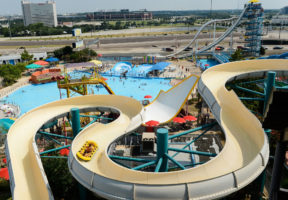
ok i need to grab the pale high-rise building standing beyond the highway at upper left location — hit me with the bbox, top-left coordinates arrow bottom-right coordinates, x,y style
21,0 -> 58,27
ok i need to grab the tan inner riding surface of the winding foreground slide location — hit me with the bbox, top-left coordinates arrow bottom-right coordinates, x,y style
6,60 -> 288,199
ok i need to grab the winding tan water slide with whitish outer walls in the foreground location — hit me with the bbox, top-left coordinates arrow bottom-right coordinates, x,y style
6,60 -> 288,200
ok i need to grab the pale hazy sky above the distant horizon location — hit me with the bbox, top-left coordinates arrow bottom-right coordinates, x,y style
0,0 -> 288,16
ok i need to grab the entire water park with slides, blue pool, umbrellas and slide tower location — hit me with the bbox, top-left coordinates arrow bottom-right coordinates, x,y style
0,0 -> 288,200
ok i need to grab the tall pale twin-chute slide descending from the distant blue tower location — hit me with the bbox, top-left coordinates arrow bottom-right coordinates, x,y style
167,4 -> 247,57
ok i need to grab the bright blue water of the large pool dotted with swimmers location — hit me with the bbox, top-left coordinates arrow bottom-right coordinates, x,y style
1,74 -> 171,115
